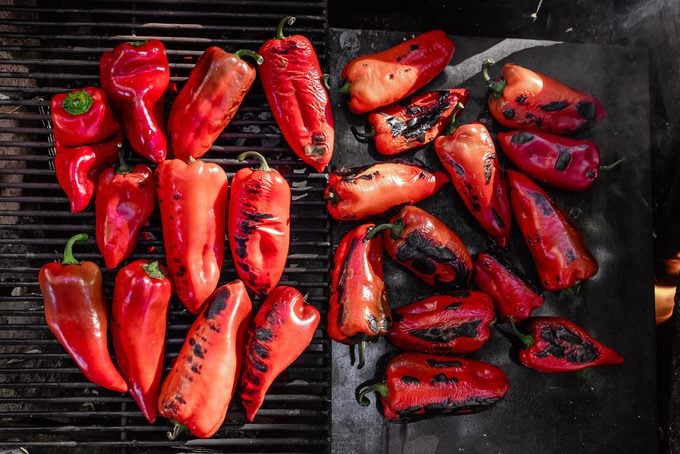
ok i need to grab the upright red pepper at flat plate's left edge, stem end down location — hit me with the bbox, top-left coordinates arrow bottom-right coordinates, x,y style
327,224 -> 392,368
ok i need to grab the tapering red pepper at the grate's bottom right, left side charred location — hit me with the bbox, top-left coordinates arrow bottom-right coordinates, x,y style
241,286 -> 321,422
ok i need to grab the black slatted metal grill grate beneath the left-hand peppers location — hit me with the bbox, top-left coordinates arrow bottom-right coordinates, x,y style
0,0 -> 331,453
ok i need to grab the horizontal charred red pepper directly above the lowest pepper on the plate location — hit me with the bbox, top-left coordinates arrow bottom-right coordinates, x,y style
387,290 -> 496,355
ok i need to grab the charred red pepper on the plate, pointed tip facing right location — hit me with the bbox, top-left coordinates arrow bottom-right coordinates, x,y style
513,317 -> 623,372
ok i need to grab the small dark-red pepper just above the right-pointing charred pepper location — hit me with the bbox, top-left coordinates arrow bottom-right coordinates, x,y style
474,252 -> 545,321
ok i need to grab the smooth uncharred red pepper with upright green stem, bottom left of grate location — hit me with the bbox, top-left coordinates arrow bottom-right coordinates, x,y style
38,233 -> 128,392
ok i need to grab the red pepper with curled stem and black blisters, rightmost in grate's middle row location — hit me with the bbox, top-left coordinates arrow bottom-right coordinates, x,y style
227,151 -> 291,296
